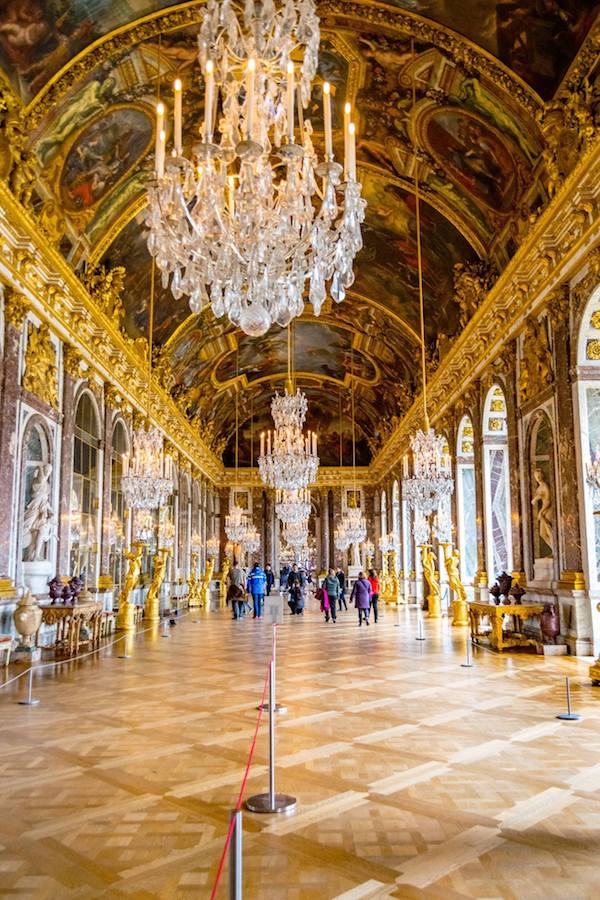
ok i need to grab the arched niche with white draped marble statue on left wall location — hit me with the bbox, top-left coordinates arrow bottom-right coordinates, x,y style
21,421 -> 54,561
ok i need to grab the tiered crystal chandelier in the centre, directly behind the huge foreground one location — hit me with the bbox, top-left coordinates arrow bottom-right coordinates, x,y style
258,384 -> 319,491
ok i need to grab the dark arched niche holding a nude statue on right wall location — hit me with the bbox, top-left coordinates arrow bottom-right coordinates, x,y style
529,413 -> 557,581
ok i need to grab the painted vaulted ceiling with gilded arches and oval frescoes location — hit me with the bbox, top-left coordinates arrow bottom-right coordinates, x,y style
0,0 -> 600,464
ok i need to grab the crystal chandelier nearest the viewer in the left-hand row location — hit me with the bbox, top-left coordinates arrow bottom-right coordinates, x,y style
121,428 -> 173,509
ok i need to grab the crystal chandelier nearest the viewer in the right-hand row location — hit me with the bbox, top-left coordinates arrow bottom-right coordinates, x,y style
403,428 -> 454,516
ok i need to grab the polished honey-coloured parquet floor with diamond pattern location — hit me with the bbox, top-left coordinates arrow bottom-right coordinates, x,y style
0,602 -> 600,900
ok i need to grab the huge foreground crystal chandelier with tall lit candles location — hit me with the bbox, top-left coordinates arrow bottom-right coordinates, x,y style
147,0 -> 366,336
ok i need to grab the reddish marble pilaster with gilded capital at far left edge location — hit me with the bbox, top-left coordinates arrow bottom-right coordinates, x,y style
0,287 -> 28,584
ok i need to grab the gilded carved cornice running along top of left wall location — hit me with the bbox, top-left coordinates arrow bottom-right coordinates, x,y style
0,180 -> 224,481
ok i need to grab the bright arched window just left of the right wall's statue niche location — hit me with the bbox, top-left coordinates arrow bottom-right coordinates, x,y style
483,384 -> 512,577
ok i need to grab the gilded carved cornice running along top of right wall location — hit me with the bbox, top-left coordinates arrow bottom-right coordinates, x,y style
370,140 -> 600,483
